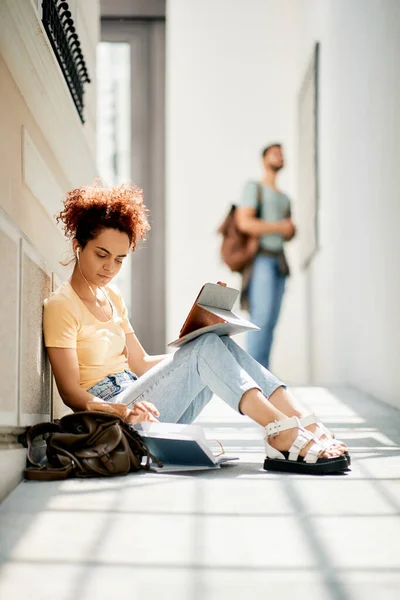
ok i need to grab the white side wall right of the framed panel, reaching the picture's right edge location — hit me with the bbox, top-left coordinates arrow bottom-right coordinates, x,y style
299,0 -> 400,407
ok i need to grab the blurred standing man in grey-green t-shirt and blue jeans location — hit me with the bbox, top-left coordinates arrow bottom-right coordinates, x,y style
236,144 -> 295,369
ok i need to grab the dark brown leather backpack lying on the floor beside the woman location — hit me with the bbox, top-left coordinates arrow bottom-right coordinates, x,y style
24,411 -> 162,481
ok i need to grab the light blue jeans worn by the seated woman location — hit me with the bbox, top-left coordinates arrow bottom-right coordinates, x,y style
88,333 -> 284,423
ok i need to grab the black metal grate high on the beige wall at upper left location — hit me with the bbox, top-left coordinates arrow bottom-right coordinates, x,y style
42,0 -> 90,123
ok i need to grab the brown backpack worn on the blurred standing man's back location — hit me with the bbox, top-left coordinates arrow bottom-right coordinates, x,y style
218,183 -> 262,273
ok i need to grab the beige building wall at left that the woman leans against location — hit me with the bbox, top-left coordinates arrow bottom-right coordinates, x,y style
0,0 -> 100,499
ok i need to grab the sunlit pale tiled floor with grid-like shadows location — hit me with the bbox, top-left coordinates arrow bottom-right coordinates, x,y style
0,388 -> 400,600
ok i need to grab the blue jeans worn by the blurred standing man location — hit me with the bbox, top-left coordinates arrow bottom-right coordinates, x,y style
247,254 -> 286,369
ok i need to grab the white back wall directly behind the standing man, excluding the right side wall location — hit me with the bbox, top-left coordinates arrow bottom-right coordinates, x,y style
167,0 -> 306,382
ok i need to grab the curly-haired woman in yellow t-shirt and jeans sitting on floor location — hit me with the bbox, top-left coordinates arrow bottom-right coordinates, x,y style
44,185 -> 349,474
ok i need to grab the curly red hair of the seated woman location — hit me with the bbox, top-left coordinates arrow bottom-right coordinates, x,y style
56,183 -> 150,251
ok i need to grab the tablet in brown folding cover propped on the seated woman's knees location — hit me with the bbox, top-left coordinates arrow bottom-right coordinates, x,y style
168,283 -> 260,347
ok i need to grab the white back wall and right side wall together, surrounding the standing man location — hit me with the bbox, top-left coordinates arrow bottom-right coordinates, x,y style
167,0 -> 400,406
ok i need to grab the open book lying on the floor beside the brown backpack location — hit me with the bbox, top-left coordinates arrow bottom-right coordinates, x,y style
138,421 -> 239,473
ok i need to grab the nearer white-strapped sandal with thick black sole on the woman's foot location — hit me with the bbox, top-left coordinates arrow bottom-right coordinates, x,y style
264,417 -> 348,475
